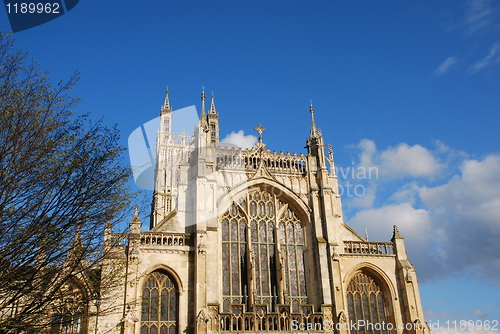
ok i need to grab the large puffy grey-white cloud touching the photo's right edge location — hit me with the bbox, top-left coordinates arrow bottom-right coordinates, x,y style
419,154 -> 500,283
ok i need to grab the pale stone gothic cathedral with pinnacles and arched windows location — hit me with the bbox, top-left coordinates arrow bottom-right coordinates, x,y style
97,91 -> 429,334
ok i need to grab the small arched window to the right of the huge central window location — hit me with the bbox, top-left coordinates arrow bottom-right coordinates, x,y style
347,271 -> 391,334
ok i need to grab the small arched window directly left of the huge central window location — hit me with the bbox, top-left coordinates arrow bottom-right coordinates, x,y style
141,271 -> 179,334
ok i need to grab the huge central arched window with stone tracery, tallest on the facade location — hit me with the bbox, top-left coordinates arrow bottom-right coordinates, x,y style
221,190 -> 307,312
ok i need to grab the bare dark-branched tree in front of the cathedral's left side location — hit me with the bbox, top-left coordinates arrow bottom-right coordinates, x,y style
0,33 -> 133,333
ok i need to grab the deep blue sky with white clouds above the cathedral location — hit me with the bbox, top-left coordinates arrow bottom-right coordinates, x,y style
0,0 -> 500,333
